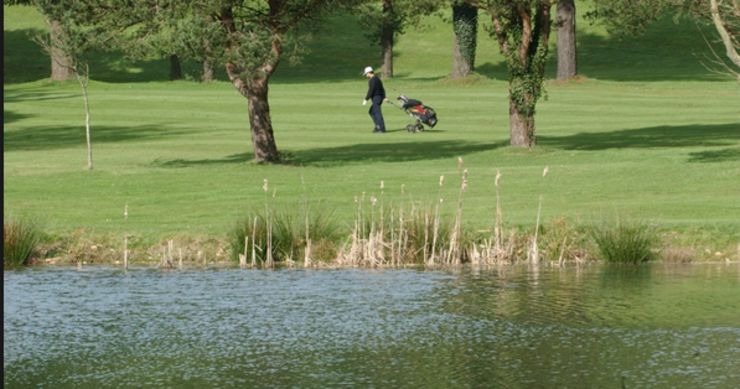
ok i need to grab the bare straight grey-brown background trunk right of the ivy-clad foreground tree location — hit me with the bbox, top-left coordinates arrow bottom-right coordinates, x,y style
556,0 -> 578,80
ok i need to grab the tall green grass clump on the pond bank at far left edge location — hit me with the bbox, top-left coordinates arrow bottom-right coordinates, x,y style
3,215 -> 41,266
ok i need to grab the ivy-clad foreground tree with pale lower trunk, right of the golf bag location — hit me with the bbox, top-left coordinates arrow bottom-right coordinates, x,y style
467,0 -> 552,147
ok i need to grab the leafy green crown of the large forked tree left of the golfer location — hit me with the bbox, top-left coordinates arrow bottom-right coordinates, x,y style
98,0 -> 341,80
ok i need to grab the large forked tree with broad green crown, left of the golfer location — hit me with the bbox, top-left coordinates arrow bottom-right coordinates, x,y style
89,0 -> 353,163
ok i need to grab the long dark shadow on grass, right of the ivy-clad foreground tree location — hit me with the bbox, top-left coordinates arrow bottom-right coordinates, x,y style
537,123 -> 740,162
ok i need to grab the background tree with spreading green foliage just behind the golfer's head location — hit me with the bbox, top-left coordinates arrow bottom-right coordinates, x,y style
350,0 -> 442,78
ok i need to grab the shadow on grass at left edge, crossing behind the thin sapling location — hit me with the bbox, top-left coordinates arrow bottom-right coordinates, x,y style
3,123 -> 186,151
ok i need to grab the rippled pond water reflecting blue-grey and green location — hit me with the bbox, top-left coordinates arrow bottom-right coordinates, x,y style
3,264 -> 740,389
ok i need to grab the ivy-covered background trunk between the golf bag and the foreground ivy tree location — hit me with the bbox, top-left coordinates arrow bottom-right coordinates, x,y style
450,1 -> 478,78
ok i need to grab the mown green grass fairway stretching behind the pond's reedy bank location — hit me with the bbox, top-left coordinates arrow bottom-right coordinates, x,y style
3,7 -> 740,260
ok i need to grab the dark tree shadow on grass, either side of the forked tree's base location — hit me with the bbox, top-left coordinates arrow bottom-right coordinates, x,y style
154,141 -> 508,168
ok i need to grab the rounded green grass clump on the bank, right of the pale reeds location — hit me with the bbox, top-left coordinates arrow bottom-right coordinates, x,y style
588,215 -> 659,264
